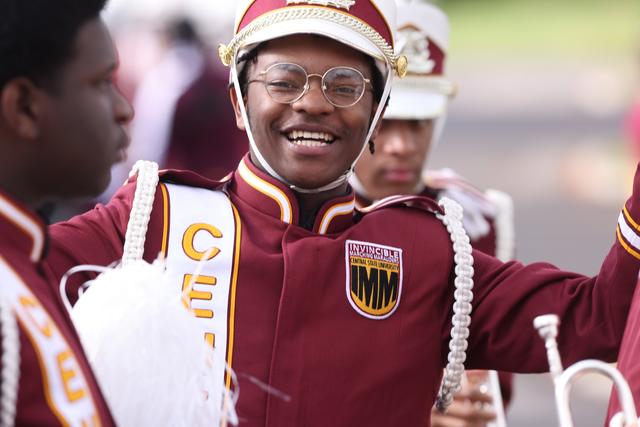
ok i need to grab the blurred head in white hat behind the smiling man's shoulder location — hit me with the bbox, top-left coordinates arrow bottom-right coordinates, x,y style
351,1 -> 455,200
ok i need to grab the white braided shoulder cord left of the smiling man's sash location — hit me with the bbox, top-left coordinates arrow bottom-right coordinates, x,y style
122,160 -> 158,265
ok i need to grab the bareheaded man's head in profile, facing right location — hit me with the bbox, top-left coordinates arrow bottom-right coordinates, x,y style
0,0 -> 132,205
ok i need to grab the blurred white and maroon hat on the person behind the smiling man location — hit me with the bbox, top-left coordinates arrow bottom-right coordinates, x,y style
384,0 -> 456,120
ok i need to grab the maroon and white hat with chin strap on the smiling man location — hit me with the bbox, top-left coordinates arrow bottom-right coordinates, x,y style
218,0 -> 407,193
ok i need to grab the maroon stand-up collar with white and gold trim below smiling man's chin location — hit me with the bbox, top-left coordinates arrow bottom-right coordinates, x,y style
231,155 -> 355,234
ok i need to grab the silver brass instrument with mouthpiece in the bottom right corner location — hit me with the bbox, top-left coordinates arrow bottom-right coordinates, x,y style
533,314 -> 640,427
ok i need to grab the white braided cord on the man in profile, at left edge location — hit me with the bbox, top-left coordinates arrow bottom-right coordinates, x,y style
0,295 -> 20,427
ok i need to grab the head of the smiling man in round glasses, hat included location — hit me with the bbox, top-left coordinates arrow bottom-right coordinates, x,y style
220,0 -> 404,199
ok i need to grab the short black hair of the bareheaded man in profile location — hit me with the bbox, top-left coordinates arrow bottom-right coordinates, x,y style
0,0 -> 107,89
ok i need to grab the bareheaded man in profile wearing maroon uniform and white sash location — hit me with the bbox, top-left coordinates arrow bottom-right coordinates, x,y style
0,0 -> 132,426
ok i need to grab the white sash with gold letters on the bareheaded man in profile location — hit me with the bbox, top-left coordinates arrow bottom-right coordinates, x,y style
0,257 -> 100,426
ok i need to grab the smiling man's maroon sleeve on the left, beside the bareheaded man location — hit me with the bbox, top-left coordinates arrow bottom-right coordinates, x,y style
44,181 -> 163,301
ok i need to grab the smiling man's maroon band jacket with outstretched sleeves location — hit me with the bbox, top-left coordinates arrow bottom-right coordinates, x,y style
49,157 -> 640,426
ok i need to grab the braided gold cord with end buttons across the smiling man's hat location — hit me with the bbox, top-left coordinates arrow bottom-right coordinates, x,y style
218,7 -> 408,77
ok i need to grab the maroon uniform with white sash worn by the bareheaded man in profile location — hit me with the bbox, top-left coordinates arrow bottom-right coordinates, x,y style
0,190 -> 114,426
